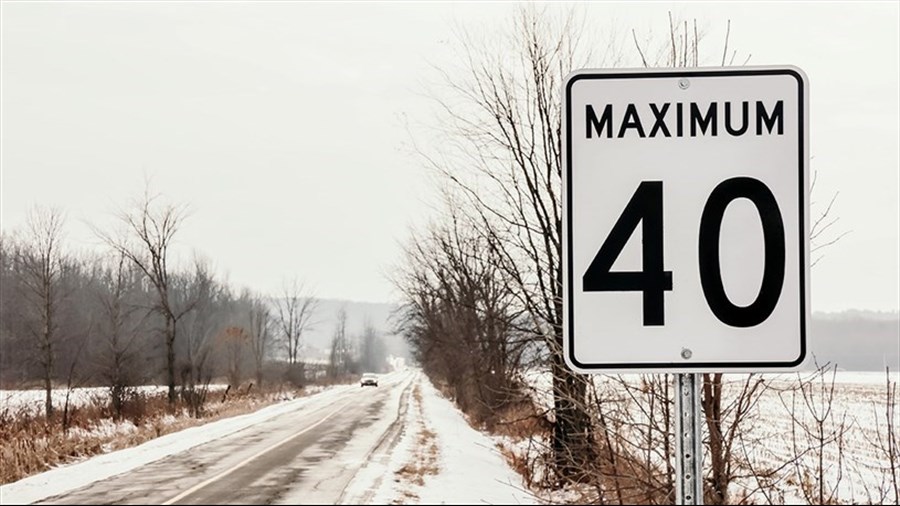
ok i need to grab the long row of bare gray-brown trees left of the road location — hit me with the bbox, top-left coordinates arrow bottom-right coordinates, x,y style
0,192 -> 386,418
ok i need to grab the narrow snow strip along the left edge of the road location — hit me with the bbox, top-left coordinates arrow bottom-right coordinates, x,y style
0,385 -> 356,504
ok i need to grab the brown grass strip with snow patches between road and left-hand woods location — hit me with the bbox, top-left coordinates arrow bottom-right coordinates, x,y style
0,375 -> 372,484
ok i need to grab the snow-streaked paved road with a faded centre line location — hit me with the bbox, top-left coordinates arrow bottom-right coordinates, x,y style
41,373 -> 415,504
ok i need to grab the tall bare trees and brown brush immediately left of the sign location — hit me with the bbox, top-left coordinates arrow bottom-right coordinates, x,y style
396,9 -> 605,483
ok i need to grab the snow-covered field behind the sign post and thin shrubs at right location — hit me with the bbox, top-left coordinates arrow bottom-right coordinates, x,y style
527,371 -> 900,504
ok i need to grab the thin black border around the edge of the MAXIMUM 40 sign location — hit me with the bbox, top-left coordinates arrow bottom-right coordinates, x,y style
563,68 -> 807,371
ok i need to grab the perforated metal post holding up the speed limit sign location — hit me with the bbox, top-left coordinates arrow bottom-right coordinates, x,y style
675,374 -> 703,504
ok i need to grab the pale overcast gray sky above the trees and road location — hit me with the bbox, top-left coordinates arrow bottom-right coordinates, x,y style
0,1 -> 900,311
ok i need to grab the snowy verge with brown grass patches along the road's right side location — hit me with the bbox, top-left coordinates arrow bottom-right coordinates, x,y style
347,374 -> 537,504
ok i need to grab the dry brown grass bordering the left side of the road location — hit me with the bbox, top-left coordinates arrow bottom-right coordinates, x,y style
0,389 -> 312,484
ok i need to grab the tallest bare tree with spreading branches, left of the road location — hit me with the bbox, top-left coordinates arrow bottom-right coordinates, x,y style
97,184 -> 192,404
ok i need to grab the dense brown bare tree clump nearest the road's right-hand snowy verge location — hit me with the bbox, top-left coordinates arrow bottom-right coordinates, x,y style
396,213 -> 534,427
